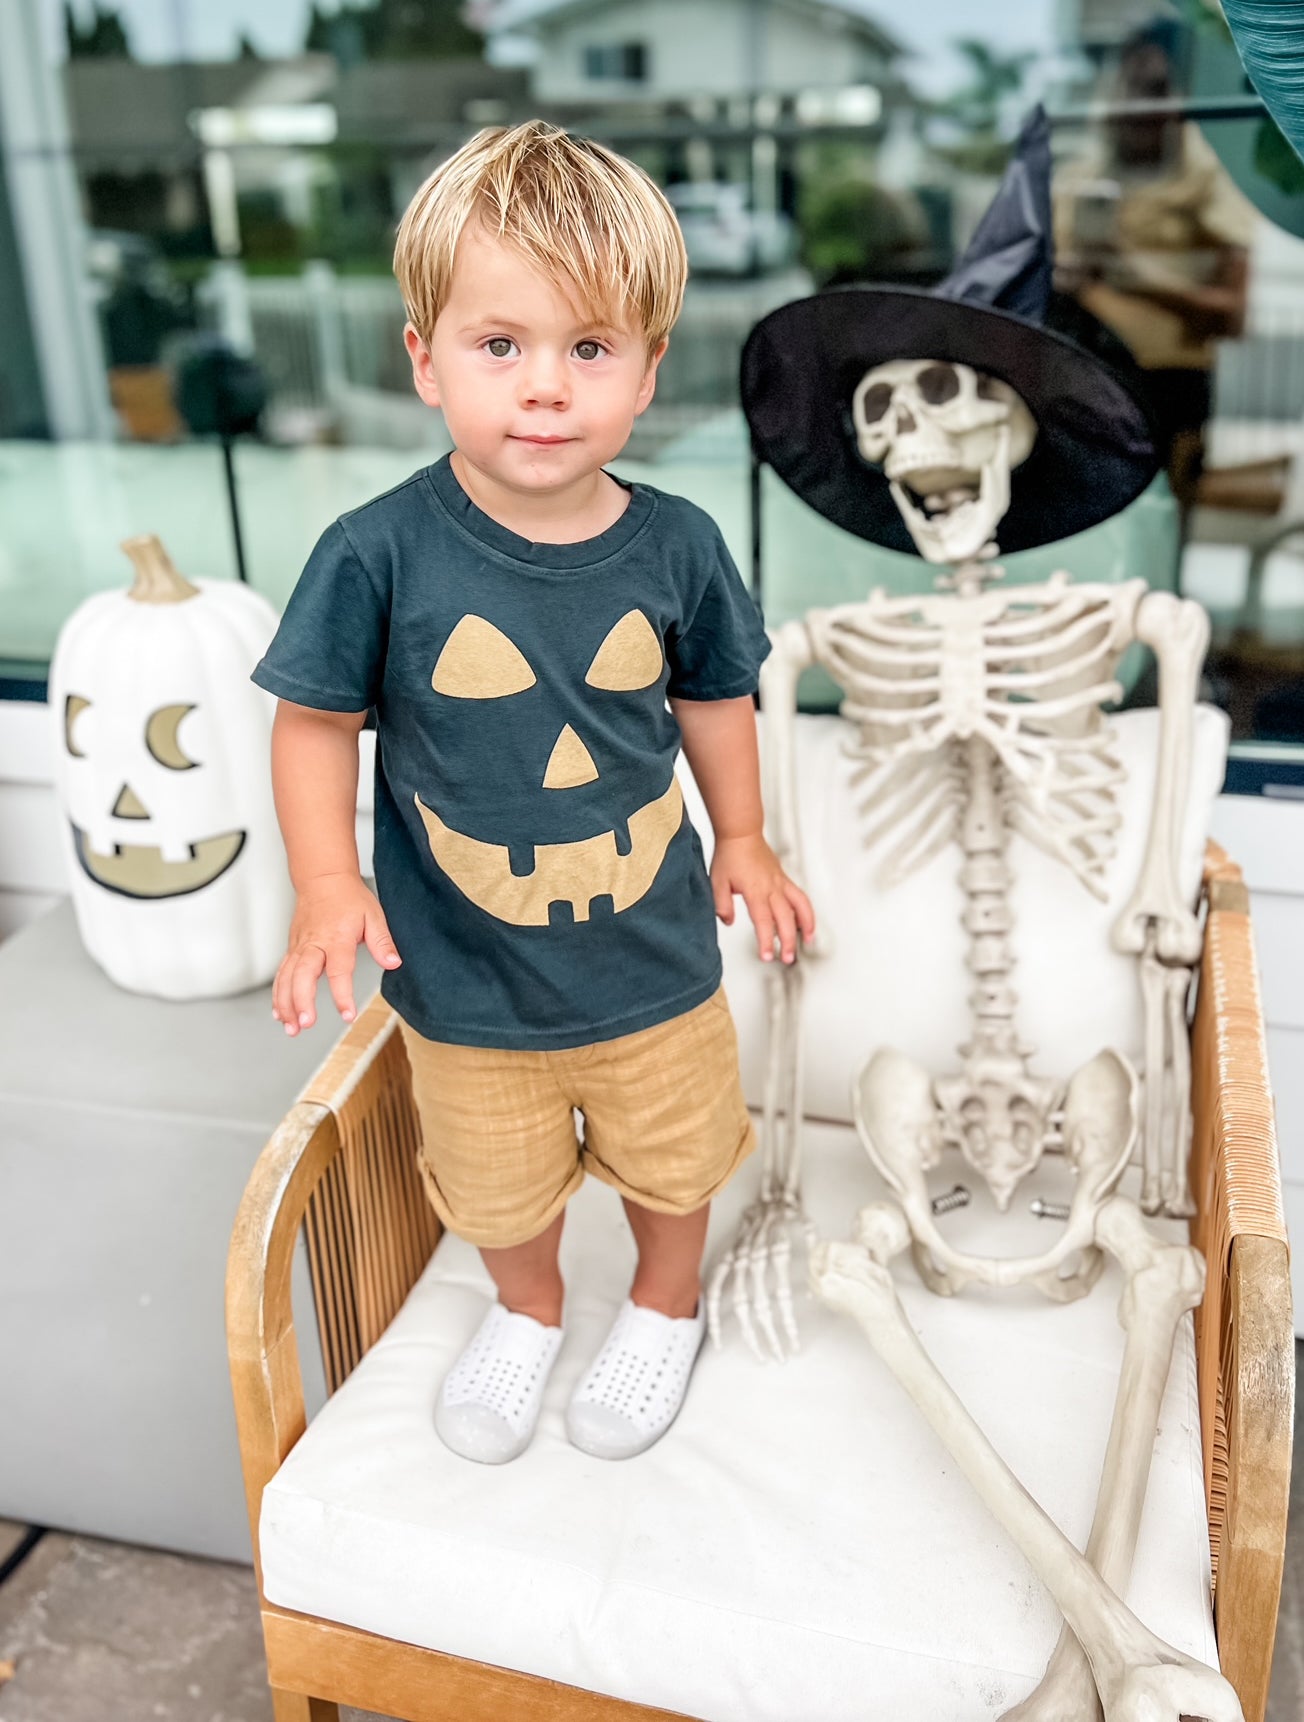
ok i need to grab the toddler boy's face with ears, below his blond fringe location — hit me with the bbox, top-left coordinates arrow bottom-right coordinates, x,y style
405,226 -> 667,494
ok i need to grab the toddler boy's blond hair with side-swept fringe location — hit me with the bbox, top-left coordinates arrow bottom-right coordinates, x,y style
394,119 -> 687,353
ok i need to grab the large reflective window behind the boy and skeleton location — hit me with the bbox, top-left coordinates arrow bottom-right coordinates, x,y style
0,0 -> 1304,761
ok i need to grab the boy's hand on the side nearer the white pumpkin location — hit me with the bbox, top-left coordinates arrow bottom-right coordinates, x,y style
272,873 -> 401,1035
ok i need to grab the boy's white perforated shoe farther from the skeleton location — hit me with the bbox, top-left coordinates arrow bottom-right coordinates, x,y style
434,1304 -> 562,1465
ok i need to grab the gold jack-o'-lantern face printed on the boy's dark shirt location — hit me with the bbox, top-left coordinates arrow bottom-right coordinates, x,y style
415,610 -> 684,926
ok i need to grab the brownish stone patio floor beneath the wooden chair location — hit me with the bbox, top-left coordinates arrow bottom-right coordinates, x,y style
0,1343 -> 1304,1722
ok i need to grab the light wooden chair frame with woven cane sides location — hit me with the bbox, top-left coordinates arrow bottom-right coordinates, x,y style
227,846 -> 1295,1722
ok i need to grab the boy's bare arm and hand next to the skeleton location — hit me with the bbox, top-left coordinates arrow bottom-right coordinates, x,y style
670,694 -> 815,963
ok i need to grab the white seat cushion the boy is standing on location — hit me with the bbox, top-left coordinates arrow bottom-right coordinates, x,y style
260,1124 -> 1216,1722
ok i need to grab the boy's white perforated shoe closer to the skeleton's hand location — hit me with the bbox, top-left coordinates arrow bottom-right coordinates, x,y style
567,1298 -> 706,1459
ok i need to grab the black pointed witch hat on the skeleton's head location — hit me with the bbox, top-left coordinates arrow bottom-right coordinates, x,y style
741,107 -> 1159,551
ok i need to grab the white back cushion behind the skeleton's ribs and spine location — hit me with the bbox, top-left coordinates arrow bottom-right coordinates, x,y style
684,706 -> 1228,1123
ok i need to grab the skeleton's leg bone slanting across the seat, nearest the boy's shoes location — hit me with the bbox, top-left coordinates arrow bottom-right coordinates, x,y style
811,1239 -> 1244,1722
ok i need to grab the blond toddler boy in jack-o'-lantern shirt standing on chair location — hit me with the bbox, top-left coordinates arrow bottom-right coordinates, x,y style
255,121 -> 813,1462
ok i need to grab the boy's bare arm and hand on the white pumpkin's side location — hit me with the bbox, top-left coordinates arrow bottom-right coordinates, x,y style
272,699 -> 400,1035
